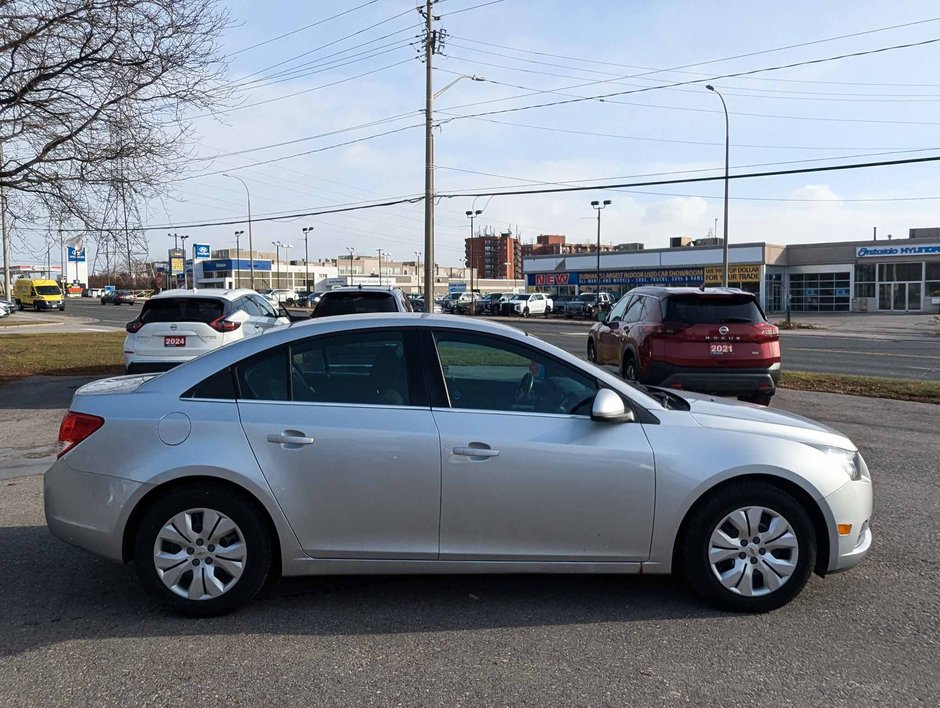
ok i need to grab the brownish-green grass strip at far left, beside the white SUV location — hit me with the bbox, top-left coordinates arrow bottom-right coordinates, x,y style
0,332 -> 125,381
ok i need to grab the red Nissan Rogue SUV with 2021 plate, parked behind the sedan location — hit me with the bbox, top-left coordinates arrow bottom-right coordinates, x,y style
587,287 -> 780,405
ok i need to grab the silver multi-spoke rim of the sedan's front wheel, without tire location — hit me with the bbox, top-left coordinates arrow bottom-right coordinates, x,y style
708,506 -> 800,597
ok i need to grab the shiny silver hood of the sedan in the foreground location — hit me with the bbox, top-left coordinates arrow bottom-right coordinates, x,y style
673,391 -> 857,450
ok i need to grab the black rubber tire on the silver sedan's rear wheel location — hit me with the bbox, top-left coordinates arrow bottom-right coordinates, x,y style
134,484 -> 273,617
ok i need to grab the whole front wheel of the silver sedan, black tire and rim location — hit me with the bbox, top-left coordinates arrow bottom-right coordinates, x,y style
678,481 -> 816,612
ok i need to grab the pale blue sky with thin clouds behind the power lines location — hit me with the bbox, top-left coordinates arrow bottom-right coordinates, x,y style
86,0 -> 940,265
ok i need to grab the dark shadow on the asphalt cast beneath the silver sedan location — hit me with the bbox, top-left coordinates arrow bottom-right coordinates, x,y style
0,526 -> 721,657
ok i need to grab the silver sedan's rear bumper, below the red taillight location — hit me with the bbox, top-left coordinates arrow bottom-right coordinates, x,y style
43,459 -> 150,561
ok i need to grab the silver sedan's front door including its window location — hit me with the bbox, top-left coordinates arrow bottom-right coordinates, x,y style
427,330 -> 655,561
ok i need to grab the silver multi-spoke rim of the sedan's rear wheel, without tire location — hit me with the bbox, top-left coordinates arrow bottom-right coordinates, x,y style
153,508 -> 247,600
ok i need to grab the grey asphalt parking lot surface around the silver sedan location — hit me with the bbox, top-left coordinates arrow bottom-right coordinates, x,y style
0,387 -> 940,706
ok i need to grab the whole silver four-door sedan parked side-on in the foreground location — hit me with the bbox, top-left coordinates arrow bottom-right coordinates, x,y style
45,314 -> 872,615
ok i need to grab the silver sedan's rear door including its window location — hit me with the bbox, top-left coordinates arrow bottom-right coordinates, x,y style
237,330 -> 441,559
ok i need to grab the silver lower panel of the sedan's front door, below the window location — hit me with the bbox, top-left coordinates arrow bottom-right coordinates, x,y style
434,409 -> 655,561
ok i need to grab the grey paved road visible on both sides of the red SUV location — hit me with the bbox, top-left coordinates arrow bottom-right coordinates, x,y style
510,319 -> 940,381
